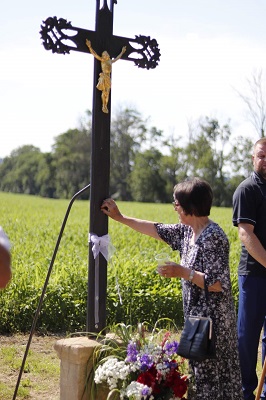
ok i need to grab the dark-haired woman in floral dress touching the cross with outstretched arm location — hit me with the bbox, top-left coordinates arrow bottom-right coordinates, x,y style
101,178 -> 243,400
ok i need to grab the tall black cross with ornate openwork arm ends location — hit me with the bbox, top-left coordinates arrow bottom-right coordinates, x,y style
40,0 -> 160,332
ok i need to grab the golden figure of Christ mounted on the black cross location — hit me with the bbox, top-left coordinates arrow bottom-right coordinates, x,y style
86,39 -> 127,113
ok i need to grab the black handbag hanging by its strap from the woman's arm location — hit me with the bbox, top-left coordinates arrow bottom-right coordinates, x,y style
177,280 -> 216,361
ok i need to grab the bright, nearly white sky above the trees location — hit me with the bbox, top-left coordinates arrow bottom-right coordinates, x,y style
0,0 -> 266,158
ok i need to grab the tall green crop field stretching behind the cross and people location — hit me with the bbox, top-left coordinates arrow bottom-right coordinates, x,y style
0,193 -> 240,334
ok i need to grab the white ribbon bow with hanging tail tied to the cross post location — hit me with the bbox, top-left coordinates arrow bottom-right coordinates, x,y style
89,233 -> 115,328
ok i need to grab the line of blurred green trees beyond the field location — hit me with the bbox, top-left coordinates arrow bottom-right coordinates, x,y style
0,107 -> 253,206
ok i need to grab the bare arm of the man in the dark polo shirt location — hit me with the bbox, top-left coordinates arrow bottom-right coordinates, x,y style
238,223 -> 266,268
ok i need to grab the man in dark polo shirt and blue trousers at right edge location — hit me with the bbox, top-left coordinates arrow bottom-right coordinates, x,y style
233,138 -> 266,400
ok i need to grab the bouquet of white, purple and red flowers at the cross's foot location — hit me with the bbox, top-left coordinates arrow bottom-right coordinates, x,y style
94,327 -> 188,400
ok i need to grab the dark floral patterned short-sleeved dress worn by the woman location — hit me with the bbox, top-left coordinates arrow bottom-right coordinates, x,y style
155,222 -> 243,400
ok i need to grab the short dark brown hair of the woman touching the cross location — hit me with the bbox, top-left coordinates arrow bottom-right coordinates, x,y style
174,178 -> 213,217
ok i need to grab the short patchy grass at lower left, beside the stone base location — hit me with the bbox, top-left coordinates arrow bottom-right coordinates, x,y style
0,335 -> 60,400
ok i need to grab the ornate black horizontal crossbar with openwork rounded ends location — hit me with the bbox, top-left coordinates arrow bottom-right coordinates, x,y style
40,17 -> 161,69
